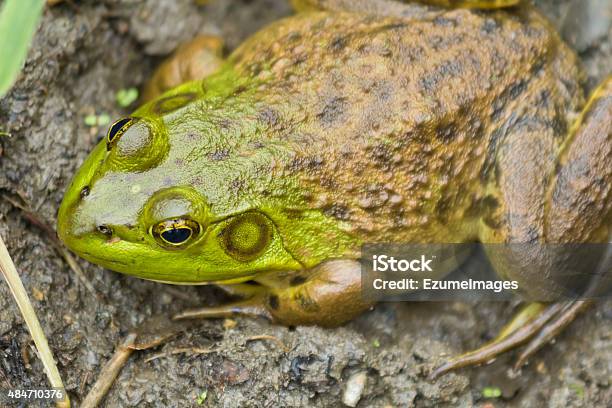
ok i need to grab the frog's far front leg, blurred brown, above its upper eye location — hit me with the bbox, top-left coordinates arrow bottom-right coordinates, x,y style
142,35 -> 223,102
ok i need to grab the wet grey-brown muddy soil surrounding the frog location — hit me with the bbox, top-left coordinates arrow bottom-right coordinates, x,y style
0,0 -> 612,407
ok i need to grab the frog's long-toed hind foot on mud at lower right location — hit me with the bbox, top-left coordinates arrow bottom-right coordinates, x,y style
430,300 -> 593,379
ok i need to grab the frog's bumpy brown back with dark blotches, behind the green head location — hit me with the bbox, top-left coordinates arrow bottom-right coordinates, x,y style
231,10 -> 582,240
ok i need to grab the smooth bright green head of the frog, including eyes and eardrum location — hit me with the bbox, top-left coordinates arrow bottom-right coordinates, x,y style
58,73 -> 358,283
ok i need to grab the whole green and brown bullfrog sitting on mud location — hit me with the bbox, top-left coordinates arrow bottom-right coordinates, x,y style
57,0 -> 612,375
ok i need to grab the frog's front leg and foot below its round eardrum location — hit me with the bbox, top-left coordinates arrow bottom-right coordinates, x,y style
175,260 -> 373,327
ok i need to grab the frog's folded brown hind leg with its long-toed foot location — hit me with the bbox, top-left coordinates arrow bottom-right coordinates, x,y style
433,76 -> 612,377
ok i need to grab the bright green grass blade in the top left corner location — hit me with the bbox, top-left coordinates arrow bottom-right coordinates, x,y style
0,0 -> 45,97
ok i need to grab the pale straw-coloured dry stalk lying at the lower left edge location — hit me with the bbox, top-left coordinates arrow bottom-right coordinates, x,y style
0,231 -> 70,407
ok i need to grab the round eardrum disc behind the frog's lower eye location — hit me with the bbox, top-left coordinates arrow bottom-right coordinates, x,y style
221,213 -> 272,262
